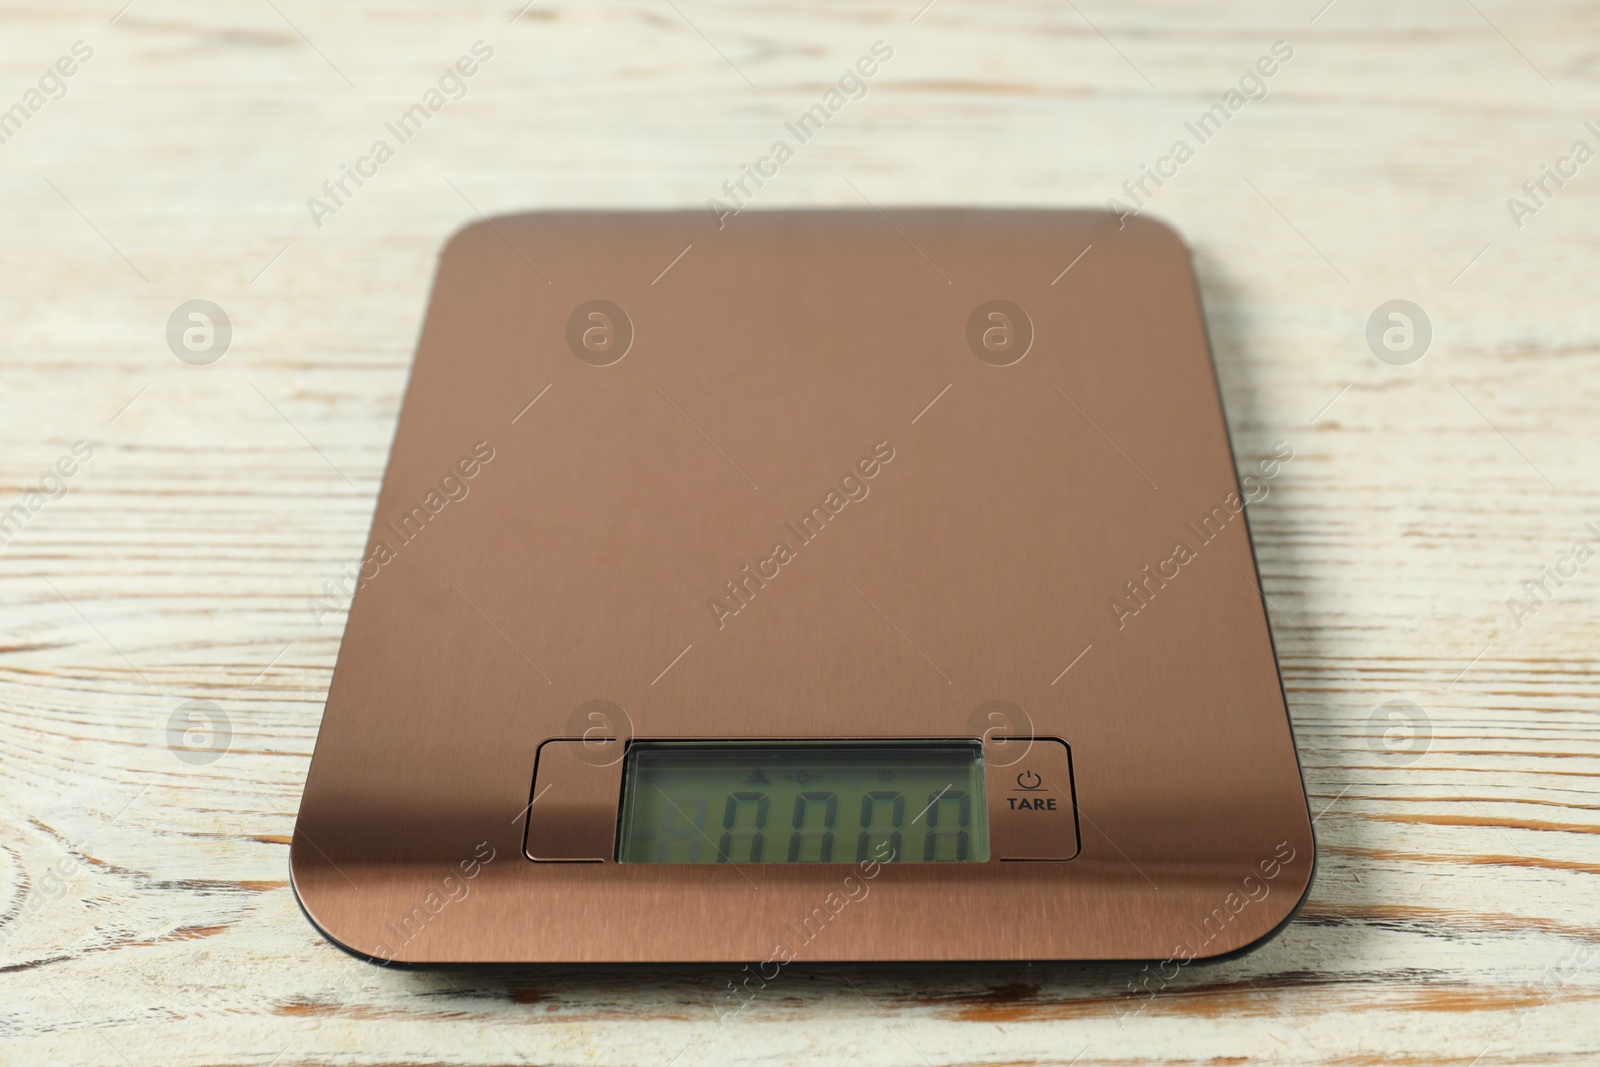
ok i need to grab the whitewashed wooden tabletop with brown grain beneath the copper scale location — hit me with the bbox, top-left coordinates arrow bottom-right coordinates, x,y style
0,0 -> 1600,1067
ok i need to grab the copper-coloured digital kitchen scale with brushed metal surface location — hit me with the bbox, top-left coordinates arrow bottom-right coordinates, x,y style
290,210 -> 1314,965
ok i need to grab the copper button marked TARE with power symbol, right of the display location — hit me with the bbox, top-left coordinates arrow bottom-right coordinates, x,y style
984,737 -> 1078,859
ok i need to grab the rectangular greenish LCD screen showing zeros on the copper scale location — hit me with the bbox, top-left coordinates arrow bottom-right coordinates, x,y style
618,742 -> 989,864
